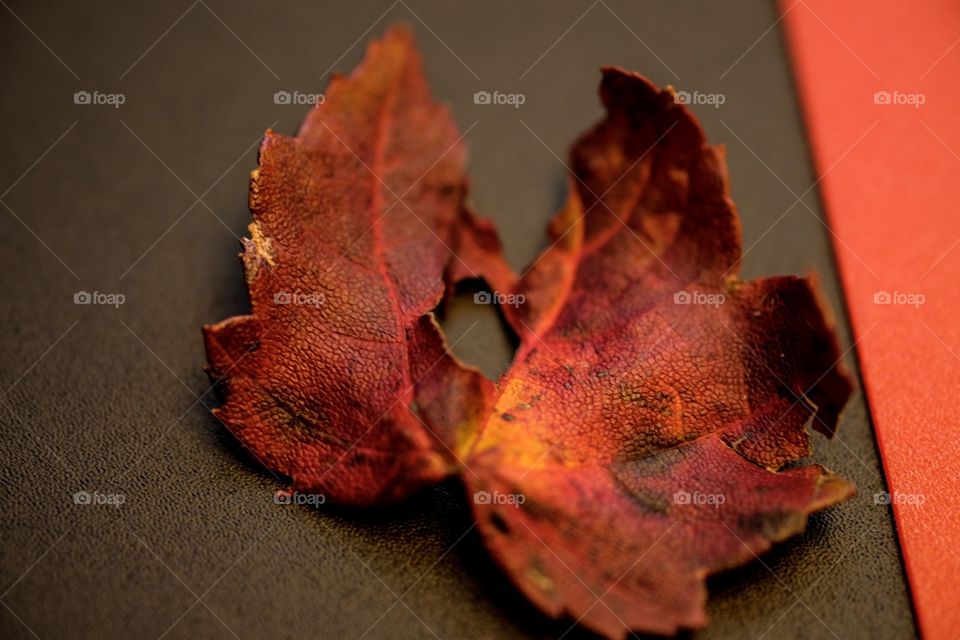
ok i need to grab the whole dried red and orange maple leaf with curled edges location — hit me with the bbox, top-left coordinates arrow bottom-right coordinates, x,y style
206,26 -> 854,637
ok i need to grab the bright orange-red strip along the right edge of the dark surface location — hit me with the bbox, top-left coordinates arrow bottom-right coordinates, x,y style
782,0 -> 960,640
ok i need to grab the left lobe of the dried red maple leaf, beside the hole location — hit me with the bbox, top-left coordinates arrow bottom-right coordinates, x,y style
204,26 -> 508,504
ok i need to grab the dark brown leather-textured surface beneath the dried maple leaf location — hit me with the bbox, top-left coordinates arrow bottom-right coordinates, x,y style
0,1 -> 915,639
